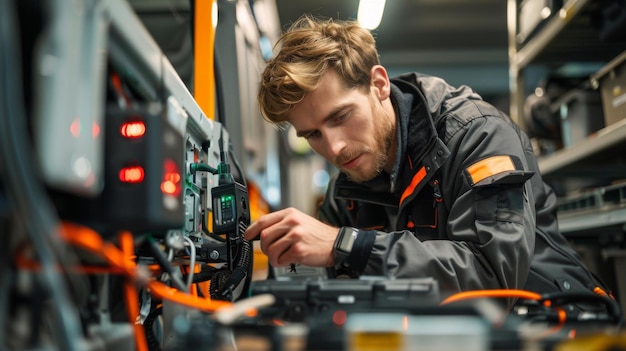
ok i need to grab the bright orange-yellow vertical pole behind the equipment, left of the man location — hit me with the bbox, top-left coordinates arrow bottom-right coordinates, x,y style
193,0 -> 217,119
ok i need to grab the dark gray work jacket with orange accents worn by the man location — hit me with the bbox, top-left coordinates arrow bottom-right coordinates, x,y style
319,73 -> 606,302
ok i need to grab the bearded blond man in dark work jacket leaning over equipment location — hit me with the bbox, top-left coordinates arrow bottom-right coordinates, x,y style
245,17 -> 604,304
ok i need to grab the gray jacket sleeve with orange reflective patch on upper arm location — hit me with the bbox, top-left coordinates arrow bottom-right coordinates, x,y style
362,116 -> 535,293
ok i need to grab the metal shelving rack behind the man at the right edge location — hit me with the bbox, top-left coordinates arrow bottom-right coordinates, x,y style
507,0 -> 626,313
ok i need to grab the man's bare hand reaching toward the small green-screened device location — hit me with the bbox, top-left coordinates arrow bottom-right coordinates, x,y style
245,208 -> 339,267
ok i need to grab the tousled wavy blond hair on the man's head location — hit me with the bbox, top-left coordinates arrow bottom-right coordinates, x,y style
258,15 -> 380,124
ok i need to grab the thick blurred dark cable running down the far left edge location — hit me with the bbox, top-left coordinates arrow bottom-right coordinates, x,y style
0,1 -> 84,350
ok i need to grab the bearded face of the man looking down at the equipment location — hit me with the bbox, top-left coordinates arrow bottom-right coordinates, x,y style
287,69 -> 396,182
